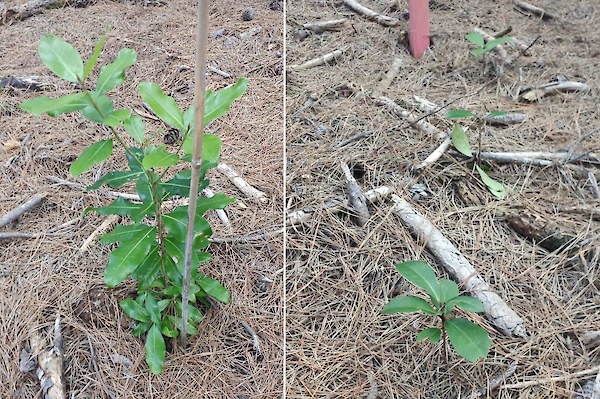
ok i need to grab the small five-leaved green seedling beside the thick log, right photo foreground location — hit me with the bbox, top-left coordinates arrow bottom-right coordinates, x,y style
382,261 -> 492,364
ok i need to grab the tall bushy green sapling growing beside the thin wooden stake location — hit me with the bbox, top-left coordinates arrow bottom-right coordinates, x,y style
21,34 -> 248,374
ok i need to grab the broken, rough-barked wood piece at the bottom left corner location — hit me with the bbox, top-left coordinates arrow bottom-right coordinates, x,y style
30,316 -> 67,399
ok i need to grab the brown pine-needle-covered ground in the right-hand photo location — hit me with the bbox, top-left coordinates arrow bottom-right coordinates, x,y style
286,0 -> 600,399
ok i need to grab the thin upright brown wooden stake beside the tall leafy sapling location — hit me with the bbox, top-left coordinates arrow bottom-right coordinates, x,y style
181,0 -> 208,349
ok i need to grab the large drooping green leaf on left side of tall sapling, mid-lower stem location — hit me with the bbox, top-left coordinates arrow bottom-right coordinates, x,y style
104,226 -> 156,288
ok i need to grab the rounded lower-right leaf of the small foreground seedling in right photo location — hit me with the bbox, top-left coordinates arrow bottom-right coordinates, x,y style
444,319 -> 492,363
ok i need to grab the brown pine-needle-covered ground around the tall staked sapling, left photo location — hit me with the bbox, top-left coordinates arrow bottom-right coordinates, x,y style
0,0 -> 283,399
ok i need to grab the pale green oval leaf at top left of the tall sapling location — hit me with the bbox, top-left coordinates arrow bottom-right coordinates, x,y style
38,35 -> 83,83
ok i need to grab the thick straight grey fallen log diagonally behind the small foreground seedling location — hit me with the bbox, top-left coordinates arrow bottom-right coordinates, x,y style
392,194 -> 527,337
